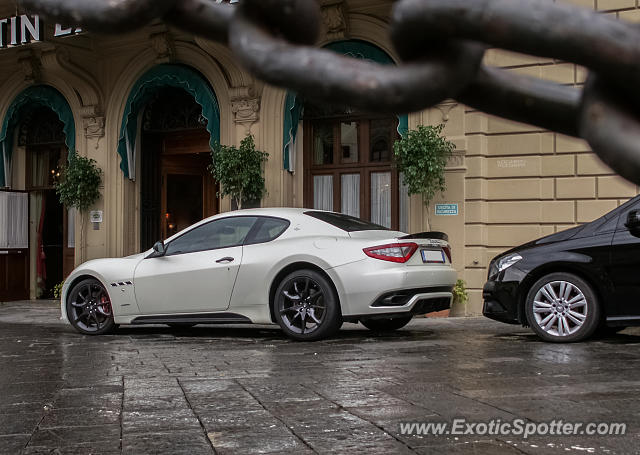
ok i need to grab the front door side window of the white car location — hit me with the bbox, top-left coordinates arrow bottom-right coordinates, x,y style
166,216 -> 257,256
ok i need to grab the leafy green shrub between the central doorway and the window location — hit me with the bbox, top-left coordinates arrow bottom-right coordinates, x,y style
209,135 -> 269,209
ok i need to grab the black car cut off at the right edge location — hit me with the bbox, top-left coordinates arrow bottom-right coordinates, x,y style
483,196 -> 640,342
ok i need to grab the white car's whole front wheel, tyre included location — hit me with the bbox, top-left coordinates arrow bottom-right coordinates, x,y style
67,278 -> 116,335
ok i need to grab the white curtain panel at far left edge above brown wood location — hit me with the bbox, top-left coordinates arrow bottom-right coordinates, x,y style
0,191 -> 29,248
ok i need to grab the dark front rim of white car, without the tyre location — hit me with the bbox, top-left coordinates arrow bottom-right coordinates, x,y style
70,283 -> 112,332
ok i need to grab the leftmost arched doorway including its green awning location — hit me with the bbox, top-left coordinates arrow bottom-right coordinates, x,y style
0,85 -> 75,300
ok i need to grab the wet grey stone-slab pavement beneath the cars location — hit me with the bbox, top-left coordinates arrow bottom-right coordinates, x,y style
0,302 -> 640,454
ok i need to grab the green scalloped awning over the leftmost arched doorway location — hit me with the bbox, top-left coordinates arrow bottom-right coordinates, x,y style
0,85 -> 76,187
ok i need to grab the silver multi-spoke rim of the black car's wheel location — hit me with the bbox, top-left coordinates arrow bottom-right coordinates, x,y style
533,281 -> 589,337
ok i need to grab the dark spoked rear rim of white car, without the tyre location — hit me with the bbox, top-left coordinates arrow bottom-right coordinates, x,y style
278,276 -> 327,334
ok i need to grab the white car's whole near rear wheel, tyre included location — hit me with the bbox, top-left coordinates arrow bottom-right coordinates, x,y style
274,269 -> 342,341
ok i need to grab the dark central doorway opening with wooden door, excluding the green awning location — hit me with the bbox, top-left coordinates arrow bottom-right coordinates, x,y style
140,87 -> 218,251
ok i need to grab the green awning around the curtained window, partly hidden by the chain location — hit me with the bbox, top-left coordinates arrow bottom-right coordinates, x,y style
283,39 -> 409,171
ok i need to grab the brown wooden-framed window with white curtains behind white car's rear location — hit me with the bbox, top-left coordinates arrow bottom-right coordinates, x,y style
303,111 -> 409,231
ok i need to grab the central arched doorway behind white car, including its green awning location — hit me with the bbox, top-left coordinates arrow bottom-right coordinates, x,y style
118,64 -> 220,251
